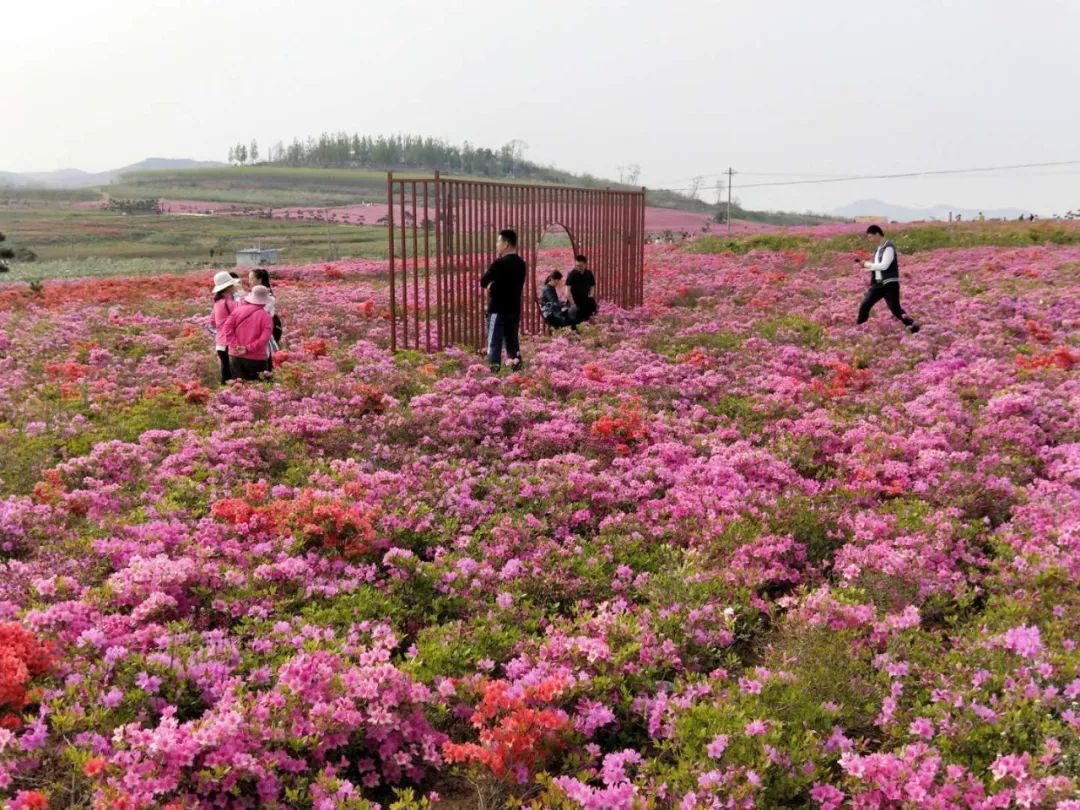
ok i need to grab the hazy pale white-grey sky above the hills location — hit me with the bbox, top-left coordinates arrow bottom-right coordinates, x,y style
6,0 -> 1080,214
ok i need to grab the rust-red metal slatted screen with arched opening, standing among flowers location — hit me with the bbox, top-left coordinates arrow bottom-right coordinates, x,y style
387,172 -> 645,351
